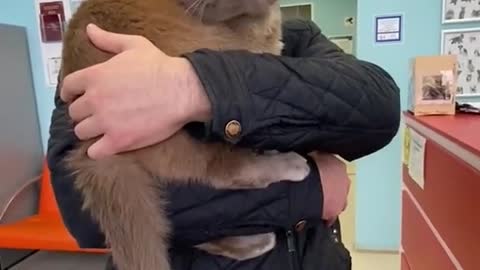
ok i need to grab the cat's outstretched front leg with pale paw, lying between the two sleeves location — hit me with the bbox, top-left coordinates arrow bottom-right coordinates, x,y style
138,132 -> 310,189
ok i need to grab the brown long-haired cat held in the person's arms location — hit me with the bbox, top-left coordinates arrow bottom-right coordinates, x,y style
60,0 -> 310,270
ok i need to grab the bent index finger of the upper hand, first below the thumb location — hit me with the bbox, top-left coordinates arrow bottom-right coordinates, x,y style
60,68 -> 90,103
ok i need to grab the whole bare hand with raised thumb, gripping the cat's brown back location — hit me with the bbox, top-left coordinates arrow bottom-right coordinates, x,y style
60,25 -> 210,159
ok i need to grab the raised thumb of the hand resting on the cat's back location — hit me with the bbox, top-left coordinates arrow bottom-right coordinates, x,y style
87,23 -> 142,54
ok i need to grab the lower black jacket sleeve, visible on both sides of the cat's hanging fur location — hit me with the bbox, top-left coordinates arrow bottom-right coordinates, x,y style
47,91 -> 323,248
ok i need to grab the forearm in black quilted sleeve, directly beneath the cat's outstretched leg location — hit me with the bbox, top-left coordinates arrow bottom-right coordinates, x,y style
168,160 -> 323,245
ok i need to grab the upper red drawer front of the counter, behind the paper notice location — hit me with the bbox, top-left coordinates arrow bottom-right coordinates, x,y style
403,138 -> 480,270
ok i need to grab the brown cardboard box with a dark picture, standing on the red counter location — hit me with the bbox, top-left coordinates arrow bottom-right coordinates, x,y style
408,55 -> 458,115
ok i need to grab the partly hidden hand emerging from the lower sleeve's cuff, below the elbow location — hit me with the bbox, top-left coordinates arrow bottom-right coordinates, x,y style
311,152 -> 350,226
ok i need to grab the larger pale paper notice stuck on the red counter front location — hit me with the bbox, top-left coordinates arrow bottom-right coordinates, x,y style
408,129 -> 427,189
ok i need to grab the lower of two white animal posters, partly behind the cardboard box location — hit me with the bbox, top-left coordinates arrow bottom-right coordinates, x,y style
441,28 -> 480,96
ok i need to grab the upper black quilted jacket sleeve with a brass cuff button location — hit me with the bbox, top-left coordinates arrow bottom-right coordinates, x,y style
185,21 -> 400,161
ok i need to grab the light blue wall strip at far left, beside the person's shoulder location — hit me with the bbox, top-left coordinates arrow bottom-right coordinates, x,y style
0,0 -> 54,152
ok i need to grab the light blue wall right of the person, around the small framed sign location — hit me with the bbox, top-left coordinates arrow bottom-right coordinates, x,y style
356,0 -> 480,250
